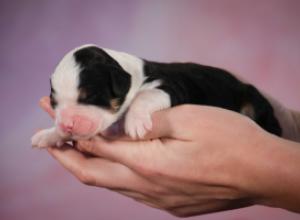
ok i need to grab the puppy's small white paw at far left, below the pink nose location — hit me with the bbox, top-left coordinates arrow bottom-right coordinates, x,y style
31,130 -> 57,148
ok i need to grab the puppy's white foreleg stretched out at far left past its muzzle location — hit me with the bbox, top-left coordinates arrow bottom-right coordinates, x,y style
31,127 -> 66,148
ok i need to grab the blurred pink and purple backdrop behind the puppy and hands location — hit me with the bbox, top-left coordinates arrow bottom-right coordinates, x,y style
0,0 -> 300,220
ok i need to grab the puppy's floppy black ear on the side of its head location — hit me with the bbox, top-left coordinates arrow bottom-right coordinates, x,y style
110,67 -> 131,98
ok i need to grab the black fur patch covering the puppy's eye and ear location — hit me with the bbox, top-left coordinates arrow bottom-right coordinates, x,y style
74,47 -> 131,111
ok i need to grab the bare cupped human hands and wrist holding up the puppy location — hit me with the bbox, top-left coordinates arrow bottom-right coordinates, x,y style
40,97 -> 300,217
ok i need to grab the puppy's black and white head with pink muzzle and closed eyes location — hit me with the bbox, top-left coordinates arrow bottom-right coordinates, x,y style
50,46 -> 131,139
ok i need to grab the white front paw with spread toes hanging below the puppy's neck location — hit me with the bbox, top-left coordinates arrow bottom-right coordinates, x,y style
125,111 -> 152,139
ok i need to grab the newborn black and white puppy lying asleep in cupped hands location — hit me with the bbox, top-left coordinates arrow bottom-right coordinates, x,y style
32,45 -> 281,148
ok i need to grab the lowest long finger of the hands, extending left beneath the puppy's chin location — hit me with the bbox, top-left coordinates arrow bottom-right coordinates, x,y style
48,145 -> 153,193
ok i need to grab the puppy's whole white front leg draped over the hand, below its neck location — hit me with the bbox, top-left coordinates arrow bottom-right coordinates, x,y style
125,89 -> 171,139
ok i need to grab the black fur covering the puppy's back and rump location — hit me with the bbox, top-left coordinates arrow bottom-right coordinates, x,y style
144,61 -> 281,135
